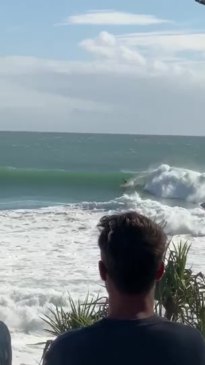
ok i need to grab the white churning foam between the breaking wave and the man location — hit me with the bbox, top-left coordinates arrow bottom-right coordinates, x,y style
0,193 -> 205,365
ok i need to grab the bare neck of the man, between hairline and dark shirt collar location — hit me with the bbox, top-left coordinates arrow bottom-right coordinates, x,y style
108,291 -> 154,320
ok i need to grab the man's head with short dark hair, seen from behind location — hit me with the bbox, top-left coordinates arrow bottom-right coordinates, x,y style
98,212 -> 167,295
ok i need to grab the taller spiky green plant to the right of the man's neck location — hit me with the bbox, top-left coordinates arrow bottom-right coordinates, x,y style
155,242 -> 205,336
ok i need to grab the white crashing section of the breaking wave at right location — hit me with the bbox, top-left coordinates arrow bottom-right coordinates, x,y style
140,165 -> 205,203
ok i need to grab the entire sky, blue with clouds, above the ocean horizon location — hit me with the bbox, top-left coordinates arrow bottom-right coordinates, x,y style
0,0 -> 205,135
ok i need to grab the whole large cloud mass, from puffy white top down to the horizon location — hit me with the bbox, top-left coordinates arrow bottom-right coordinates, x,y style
0,23 -> 205,135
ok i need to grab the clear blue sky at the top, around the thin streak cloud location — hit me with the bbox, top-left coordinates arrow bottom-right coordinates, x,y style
0,0 -> 205,59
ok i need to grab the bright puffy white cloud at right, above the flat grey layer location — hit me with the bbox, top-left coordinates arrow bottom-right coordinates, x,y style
80,32 -> 205,82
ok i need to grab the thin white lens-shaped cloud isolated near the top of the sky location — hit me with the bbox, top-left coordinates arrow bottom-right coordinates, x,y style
64,10 -> 167,26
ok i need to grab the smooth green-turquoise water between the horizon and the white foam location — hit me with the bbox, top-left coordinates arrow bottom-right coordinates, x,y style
0,132 -> 205,209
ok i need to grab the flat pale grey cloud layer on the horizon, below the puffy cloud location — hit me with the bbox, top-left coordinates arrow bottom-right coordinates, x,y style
0,51 -> 205,134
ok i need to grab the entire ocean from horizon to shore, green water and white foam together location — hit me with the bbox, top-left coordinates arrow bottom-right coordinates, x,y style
0,132 -> 205,365
